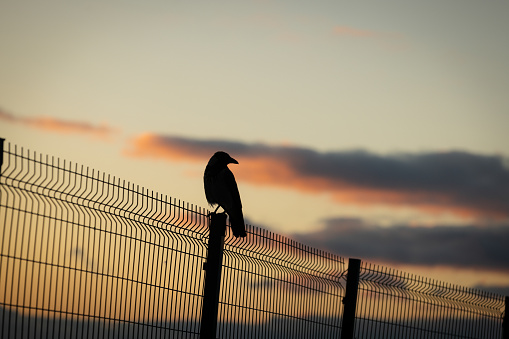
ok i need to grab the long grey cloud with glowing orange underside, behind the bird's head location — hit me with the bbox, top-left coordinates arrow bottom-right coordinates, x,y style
125,133 -> 509,218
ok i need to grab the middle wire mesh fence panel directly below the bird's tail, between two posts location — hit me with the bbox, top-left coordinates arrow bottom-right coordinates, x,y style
218,227 -> 345,338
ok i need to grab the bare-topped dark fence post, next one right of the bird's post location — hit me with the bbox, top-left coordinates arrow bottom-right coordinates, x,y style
341,258 -> 361,339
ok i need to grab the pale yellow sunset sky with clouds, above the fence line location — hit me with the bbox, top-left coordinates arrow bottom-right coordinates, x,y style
0,0 -> 509,295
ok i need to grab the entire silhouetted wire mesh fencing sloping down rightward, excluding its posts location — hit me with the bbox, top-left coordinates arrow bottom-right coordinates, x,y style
0,139 -> 505,338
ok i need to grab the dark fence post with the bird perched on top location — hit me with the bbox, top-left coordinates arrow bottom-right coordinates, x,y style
200,213 -> 226,339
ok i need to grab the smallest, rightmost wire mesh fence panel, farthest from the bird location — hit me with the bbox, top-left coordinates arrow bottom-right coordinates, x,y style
355,263 -> 504,339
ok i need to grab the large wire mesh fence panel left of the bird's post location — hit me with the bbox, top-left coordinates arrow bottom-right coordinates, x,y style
0,148 -> 207,338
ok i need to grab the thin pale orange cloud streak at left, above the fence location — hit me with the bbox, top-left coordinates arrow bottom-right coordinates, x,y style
0,110 -> 117,139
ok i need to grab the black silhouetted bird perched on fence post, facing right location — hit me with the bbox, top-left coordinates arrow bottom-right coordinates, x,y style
203,151 -> 246,238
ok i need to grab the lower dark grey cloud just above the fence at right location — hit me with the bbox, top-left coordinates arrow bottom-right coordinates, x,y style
294,218 -> 509,271
